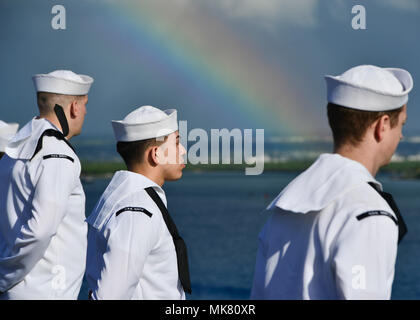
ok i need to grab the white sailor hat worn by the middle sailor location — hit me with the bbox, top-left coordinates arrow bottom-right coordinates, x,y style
112,106 -> 178,142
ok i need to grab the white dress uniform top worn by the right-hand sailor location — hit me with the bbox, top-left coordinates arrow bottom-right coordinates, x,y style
251,154 -> 398,299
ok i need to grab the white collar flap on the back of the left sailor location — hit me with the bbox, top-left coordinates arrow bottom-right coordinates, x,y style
6,117 -> 61,159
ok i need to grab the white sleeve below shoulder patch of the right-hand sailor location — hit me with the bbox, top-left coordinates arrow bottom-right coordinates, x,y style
332,215 -> 398,300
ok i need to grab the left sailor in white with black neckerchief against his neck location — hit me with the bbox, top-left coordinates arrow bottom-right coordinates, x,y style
0,70 -> 93,299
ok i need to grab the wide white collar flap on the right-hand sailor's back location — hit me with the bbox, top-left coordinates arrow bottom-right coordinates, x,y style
267,153 -> 382,213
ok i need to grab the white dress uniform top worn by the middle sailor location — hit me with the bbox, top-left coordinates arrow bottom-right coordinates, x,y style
86,171 -> 185,300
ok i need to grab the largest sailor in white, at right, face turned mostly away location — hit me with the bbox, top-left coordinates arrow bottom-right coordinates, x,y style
251,65 -> 413,299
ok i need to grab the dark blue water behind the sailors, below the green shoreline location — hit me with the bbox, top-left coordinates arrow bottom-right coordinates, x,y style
79,171 -> 420,299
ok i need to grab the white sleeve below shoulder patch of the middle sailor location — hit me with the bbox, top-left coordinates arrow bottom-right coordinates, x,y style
92,211 -> 159,300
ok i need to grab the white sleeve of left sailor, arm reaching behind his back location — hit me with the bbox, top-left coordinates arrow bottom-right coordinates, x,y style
0,154 -> 78,291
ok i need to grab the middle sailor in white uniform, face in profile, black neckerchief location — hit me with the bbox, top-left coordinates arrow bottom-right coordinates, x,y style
86,106 -> 191,300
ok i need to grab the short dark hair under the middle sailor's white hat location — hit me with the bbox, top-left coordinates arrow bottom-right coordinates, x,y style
117,136 -> 168,167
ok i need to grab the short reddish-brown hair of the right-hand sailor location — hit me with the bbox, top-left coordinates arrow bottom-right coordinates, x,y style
327,103 -> 404,148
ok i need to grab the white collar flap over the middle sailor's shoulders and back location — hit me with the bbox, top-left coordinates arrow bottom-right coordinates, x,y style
86,170 -> 167,230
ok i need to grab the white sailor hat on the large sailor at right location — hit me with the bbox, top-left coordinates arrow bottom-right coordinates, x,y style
325,65 -> 413,111
